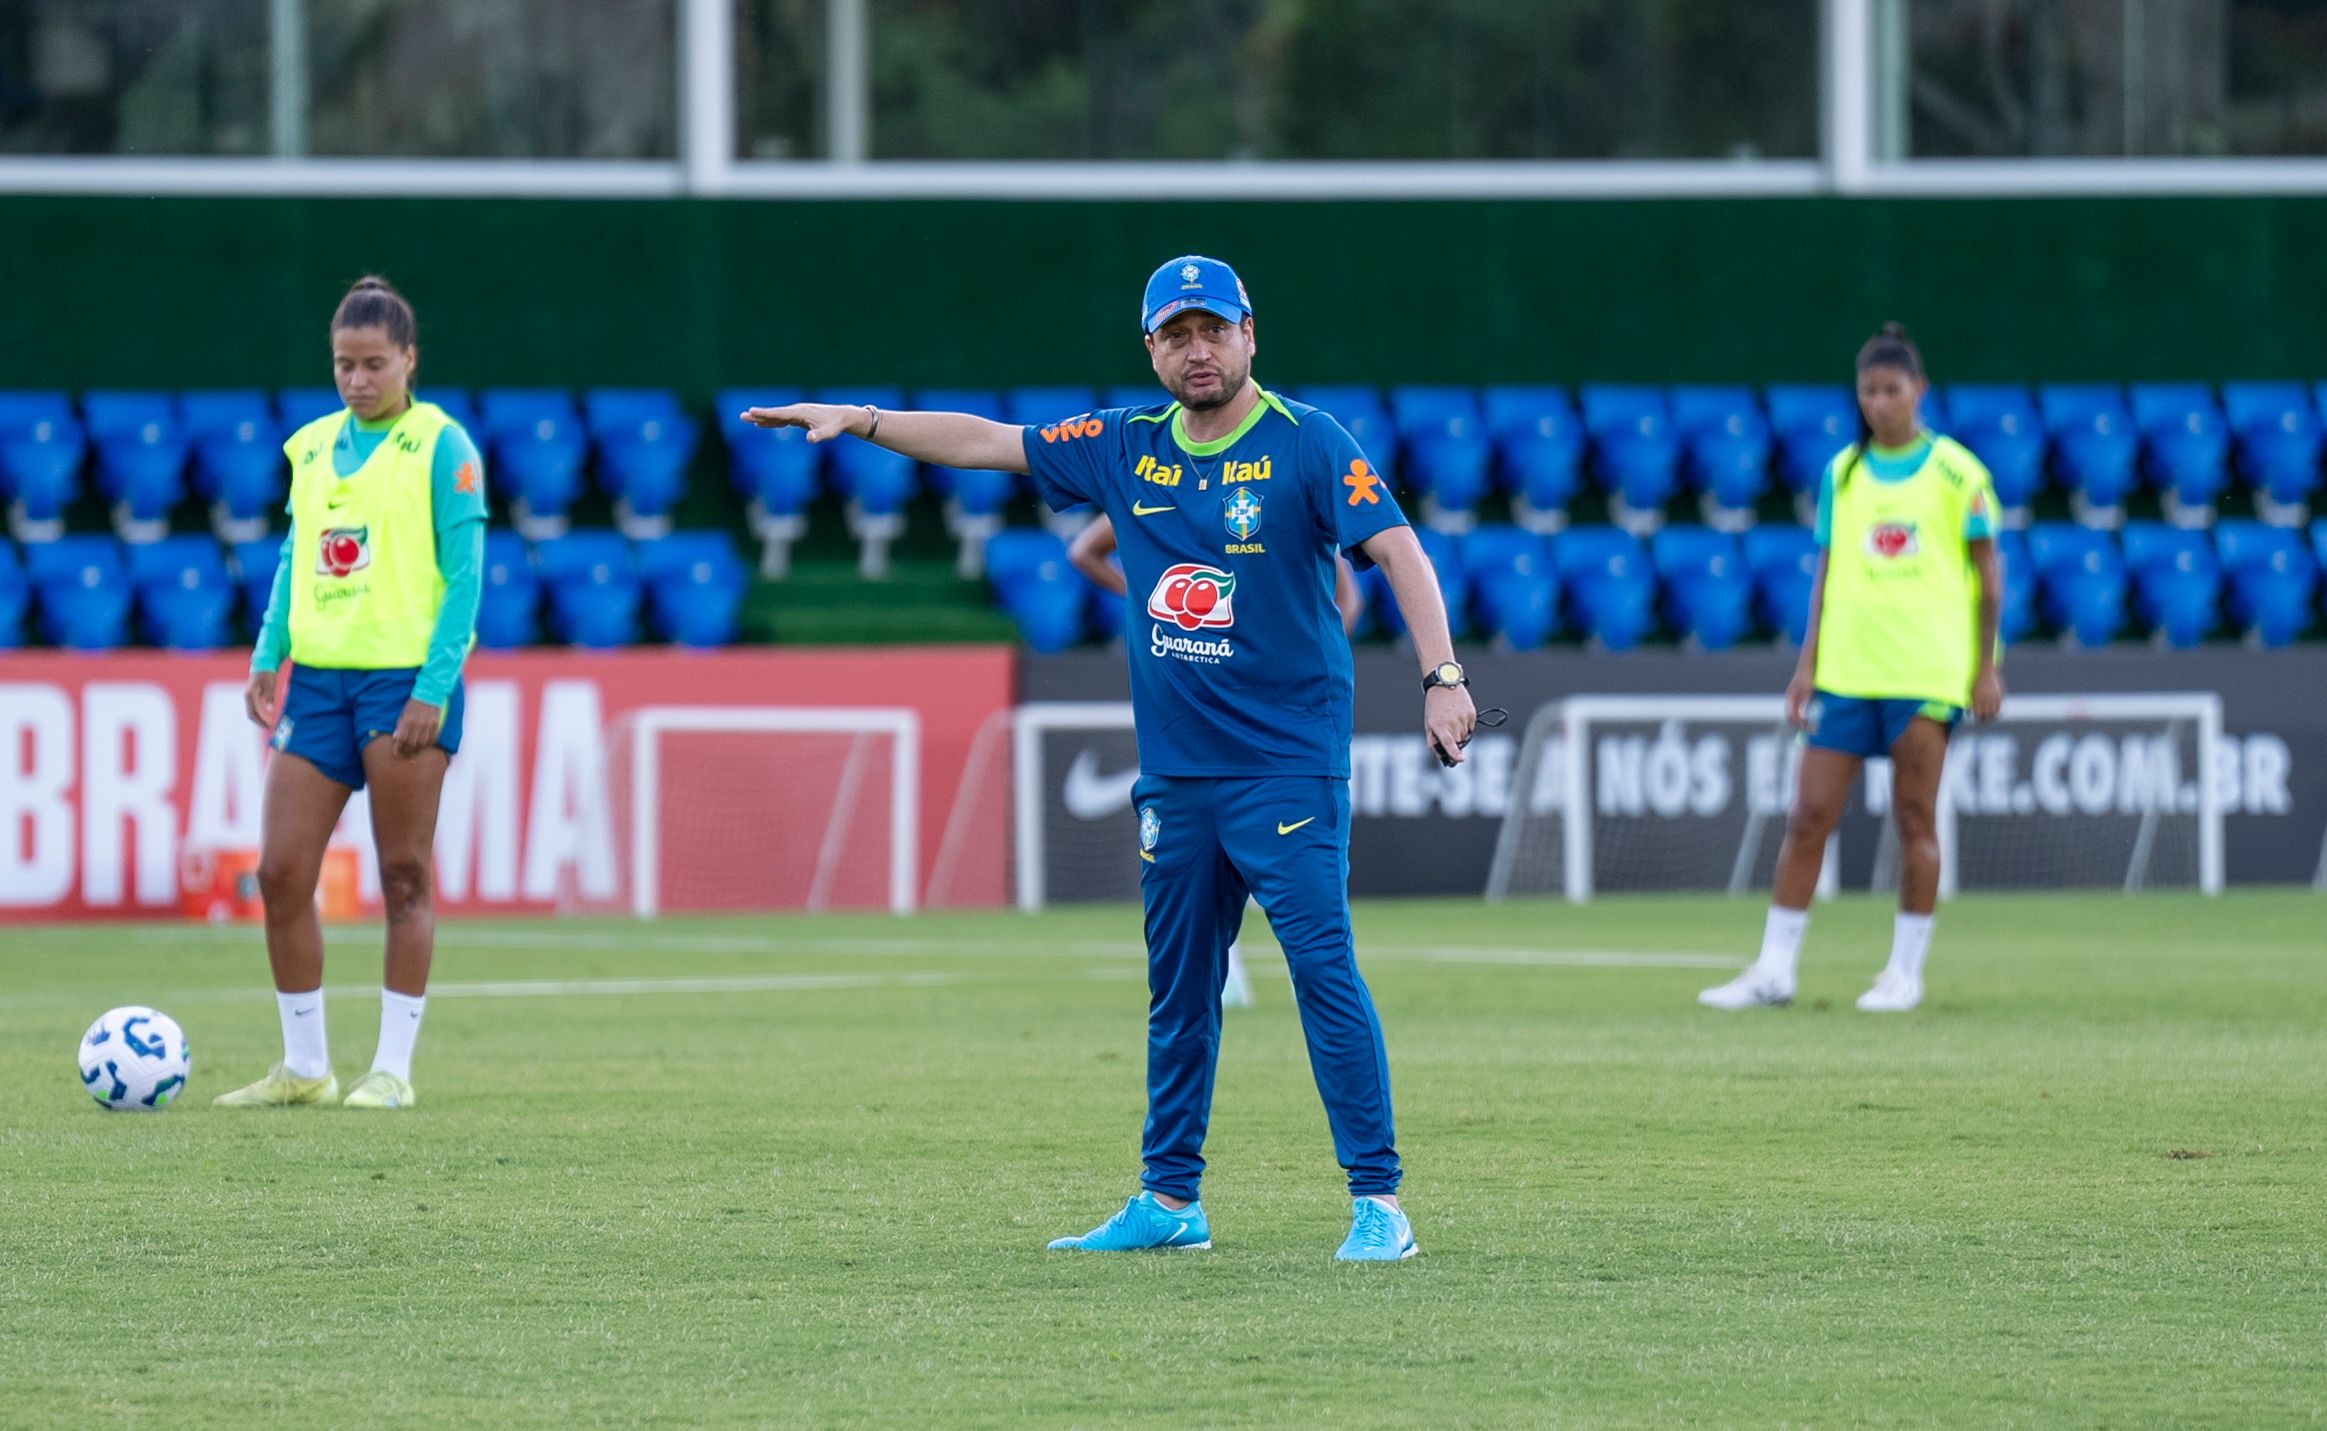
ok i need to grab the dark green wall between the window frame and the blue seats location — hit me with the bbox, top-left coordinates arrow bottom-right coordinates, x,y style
0,195 -> 2327,400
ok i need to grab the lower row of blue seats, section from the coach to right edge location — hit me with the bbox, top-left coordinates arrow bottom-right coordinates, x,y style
987,519 -> 2327,652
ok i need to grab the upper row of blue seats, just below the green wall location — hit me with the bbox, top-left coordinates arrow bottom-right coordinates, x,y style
22,382 -> 2327,563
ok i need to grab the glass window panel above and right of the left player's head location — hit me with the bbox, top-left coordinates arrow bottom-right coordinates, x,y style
307,0 -> 679,158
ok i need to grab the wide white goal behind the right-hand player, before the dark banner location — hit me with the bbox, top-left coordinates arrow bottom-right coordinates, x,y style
1487,693 -> 2222,900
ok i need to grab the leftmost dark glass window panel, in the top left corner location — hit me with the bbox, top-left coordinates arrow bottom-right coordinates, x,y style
0,0 -> 272,156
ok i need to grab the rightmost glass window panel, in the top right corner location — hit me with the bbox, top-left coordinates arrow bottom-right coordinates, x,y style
1880,0 -> 2327,158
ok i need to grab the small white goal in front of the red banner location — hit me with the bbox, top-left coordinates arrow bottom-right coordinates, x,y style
561,705 -> 921,917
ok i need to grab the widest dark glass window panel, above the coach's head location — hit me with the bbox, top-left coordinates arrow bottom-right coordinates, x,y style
868,0 -> 1817,161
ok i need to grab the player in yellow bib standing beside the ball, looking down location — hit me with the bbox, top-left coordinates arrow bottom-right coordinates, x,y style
219,277 -> 484,1108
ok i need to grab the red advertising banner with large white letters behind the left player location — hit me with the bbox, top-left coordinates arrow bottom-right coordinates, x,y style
0,647 -> 1012,924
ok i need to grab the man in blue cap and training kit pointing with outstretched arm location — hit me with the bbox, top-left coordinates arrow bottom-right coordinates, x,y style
745,256 -> 1475,1261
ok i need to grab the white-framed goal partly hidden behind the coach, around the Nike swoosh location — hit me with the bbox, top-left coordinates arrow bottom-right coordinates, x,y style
1010,700 -> 1140,910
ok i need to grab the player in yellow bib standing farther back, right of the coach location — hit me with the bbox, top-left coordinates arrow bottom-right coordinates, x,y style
1696,323 -> 2004,1012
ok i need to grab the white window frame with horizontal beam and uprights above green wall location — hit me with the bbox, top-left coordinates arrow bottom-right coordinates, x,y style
0,0 -> 2327,200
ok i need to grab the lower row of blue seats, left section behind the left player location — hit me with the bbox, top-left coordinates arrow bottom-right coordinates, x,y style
0,531 -> 749,649
